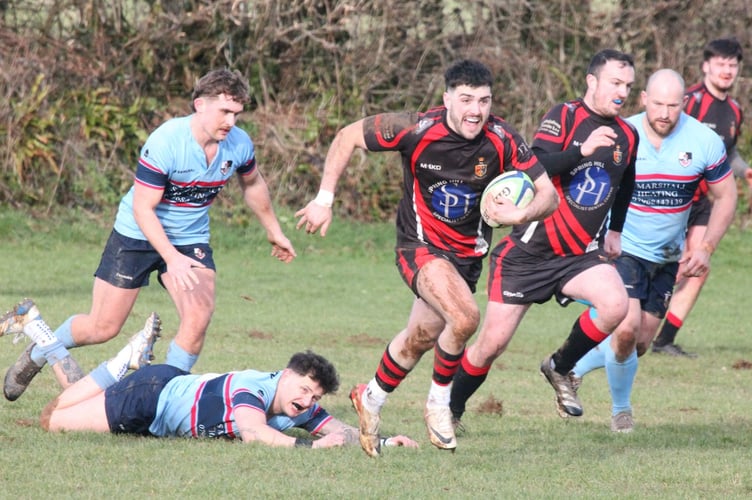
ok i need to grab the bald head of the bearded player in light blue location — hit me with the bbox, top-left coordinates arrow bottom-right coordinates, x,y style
641,69 -> 685,137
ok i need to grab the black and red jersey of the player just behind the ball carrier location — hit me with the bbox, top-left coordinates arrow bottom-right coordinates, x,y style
510,99 -> 639,258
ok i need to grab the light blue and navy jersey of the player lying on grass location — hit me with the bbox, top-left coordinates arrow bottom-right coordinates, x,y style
149,370 -> 332,439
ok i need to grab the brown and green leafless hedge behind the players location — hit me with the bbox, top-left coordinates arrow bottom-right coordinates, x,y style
0,0 -> 752,222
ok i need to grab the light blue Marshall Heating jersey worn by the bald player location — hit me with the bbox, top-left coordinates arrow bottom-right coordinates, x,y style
621,112 -> 731,264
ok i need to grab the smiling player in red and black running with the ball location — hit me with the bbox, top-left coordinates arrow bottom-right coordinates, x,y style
296,60 -> 557,456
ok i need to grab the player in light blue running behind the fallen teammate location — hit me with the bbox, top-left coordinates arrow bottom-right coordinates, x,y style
3,70 -> 295,401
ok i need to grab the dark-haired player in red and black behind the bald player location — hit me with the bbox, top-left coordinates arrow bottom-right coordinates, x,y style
652,38 -> 752,357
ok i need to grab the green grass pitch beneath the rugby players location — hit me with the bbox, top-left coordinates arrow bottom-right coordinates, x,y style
0,207 -> 752,498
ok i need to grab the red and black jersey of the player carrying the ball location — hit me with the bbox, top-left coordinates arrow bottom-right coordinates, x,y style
363,106 -> 545,258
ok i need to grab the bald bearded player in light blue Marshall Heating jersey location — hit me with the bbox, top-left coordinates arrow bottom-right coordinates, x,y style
574,69 -> 736,432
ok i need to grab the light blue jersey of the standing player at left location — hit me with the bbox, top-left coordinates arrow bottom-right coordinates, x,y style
114,115 -> 256,245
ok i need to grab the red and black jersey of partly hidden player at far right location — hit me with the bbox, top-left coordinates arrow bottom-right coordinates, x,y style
684,82 -> 744,200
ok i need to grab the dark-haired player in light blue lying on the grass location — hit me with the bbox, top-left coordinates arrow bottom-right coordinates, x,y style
0,299 -> 418,448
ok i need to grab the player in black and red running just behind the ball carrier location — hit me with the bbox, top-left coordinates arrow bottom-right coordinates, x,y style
451,49 -> 637,422
